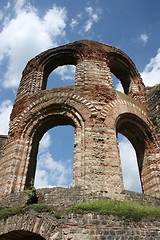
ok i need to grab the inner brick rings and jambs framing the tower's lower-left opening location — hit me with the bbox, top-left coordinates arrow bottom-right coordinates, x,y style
25,104 -> 84,188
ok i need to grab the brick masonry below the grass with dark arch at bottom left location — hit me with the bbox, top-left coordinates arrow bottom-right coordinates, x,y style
0,212 -> 160,240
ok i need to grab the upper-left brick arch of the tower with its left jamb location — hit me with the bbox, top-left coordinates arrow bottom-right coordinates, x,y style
17,44 -> 83,100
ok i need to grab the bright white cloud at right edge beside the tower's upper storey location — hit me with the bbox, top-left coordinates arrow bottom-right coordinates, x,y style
141,48 -> 160,86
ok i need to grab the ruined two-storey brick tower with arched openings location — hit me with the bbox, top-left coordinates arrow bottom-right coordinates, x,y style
0,40 -> 160,239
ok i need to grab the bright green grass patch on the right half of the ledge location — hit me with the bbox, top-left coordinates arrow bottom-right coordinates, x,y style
67,200 -> 160,220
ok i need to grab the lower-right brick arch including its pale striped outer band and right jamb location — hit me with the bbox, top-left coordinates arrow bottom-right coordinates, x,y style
100,92 -> 159,195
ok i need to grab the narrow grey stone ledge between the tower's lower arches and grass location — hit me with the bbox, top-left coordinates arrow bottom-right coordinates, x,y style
0,187 -> 160,208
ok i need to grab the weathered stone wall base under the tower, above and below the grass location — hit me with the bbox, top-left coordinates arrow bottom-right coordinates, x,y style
0,187 -> 160,240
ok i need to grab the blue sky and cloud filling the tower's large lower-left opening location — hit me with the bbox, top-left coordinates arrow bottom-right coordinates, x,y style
35,125 -> 74,188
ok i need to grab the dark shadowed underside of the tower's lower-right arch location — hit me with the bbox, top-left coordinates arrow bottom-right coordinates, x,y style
116,113 -> 153,193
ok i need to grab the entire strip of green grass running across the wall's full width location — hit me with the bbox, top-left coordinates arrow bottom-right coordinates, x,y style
0,200 -> 160,221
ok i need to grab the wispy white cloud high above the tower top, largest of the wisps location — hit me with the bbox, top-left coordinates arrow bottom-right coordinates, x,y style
84,6 -> 102,32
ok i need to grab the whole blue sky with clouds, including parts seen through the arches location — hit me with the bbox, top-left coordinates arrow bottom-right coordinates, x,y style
0,0 -> 160,191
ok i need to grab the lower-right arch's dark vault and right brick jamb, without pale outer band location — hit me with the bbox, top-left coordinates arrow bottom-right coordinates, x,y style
116,112 -> 158,194
